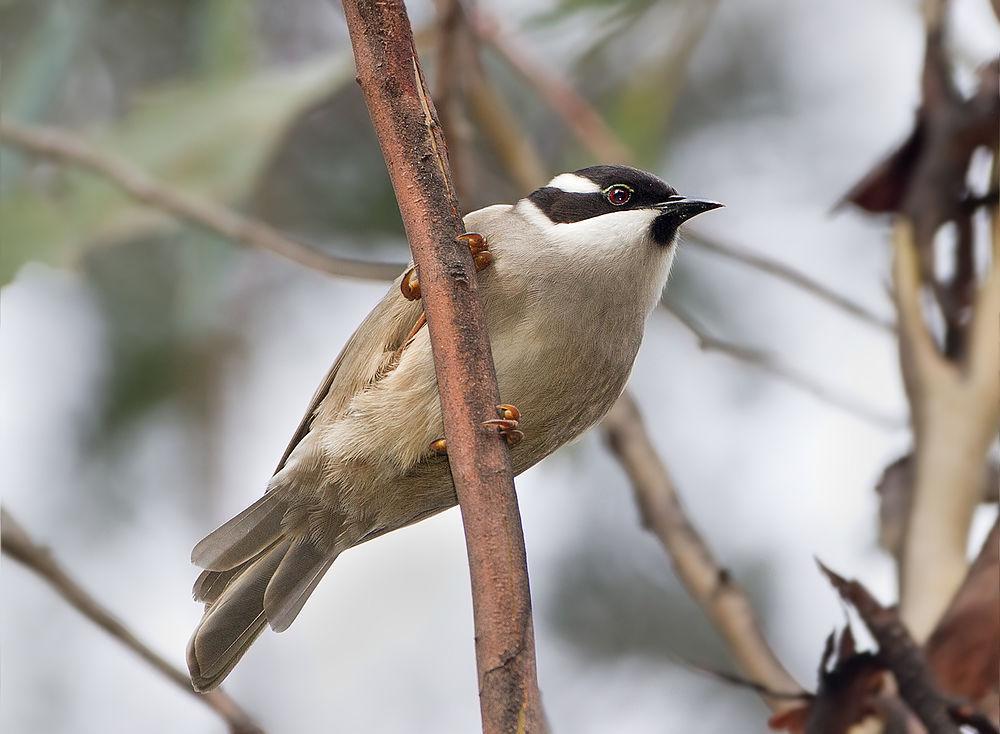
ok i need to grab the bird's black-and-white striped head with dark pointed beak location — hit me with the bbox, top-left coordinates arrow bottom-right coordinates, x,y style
518,166 -> 722,248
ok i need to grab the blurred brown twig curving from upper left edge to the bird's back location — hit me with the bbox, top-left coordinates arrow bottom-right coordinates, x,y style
0,120 -> 405,280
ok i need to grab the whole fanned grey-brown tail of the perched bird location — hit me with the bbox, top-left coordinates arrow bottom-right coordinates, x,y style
187,489 -> 337,691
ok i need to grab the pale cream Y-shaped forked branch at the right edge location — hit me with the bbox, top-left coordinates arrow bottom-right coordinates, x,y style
893,218 -> 1000,642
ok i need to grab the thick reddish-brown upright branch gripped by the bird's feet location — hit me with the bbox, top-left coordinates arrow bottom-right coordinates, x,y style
344,0 -> 544,733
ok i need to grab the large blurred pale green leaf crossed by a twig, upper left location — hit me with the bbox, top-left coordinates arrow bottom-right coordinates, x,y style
0,57 -> 351,282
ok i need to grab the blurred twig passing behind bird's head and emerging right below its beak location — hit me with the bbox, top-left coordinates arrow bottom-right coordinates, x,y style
474,11 -> 894,332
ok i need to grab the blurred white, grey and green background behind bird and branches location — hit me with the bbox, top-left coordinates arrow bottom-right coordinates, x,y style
0,0 -> 1000,734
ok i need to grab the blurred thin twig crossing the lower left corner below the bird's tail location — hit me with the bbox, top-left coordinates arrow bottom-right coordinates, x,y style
0,507 -> 263,734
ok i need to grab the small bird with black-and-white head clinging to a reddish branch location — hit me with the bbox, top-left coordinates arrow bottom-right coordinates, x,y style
187,165 -> 722,692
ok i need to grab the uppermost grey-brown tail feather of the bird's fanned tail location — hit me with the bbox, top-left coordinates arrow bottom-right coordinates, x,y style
191,488 -> 288,571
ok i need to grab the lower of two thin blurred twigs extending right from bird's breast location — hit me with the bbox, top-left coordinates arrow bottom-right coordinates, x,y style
662,300 -> 906,429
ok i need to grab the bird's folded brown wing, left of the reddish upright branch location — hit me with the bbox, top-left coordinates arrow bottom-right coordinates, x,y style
274,276 -> 422,473
